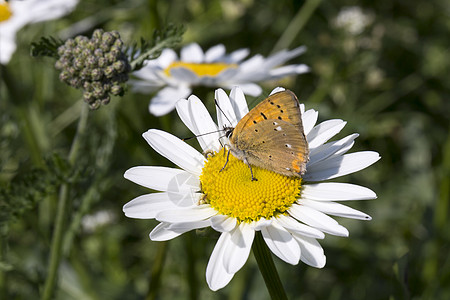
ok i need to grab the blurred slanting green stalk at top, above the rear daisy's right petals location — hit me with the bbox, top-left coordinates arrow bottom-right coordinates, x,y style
272,0 -> 322,53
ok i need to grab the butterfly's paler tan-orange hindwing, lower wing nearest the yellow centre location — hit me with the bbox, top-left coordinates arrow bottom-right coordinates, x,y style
231,120 -> 309,177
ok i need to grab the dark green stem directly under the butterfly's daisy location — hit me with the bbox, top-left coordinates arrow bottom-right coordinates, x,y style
252,231 -> 287,300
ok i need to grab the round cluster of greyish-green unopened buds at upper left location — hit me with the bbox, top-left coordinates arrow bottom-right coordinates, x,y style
55,29 -> 131,109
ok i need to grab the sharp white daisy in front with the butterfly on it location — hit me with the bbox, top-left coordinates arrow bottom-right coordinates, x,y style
123,88 -> 380,290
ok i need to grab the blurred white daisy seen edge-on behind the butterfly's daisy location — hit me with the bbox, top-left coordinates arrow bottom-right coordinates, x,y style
130,43 -> 309,116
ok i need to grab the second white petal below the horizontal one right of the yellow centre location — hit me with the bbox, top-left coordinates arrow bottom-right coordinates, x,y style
288,204 -> 348,236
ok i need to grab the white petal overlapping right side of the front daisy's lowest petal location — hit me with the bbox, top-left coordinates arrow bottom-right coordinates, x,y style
223,223 -> 255,274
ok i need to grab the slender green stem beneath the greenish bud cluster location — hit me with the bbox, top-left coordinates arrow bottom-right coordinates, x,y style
42,105 -> 89,300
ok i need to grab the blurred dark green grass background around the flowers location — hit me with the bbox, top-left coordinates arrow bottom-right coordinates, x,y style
0,0 -> 450,300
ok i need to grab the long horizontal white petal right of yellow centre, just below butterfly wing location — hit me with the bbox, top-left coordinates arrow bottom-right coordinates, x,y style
302,182 -> 377,201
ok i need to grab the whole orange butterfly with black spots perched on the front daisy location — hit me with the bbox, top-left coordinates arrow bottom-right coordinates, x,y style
225,90 -> 309,179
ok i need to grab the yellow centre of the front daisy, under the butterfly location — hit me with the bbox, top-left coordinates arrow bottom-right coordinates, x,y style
200,149 -> 301,222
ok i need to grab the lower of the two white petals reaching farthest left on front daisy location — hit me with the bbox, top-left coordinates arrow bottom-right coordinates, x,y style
123,193 -> 201,219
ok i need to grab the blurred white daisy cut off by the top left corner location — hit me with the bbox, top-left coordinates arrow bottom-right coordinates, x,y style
0,0 -> 79,65
